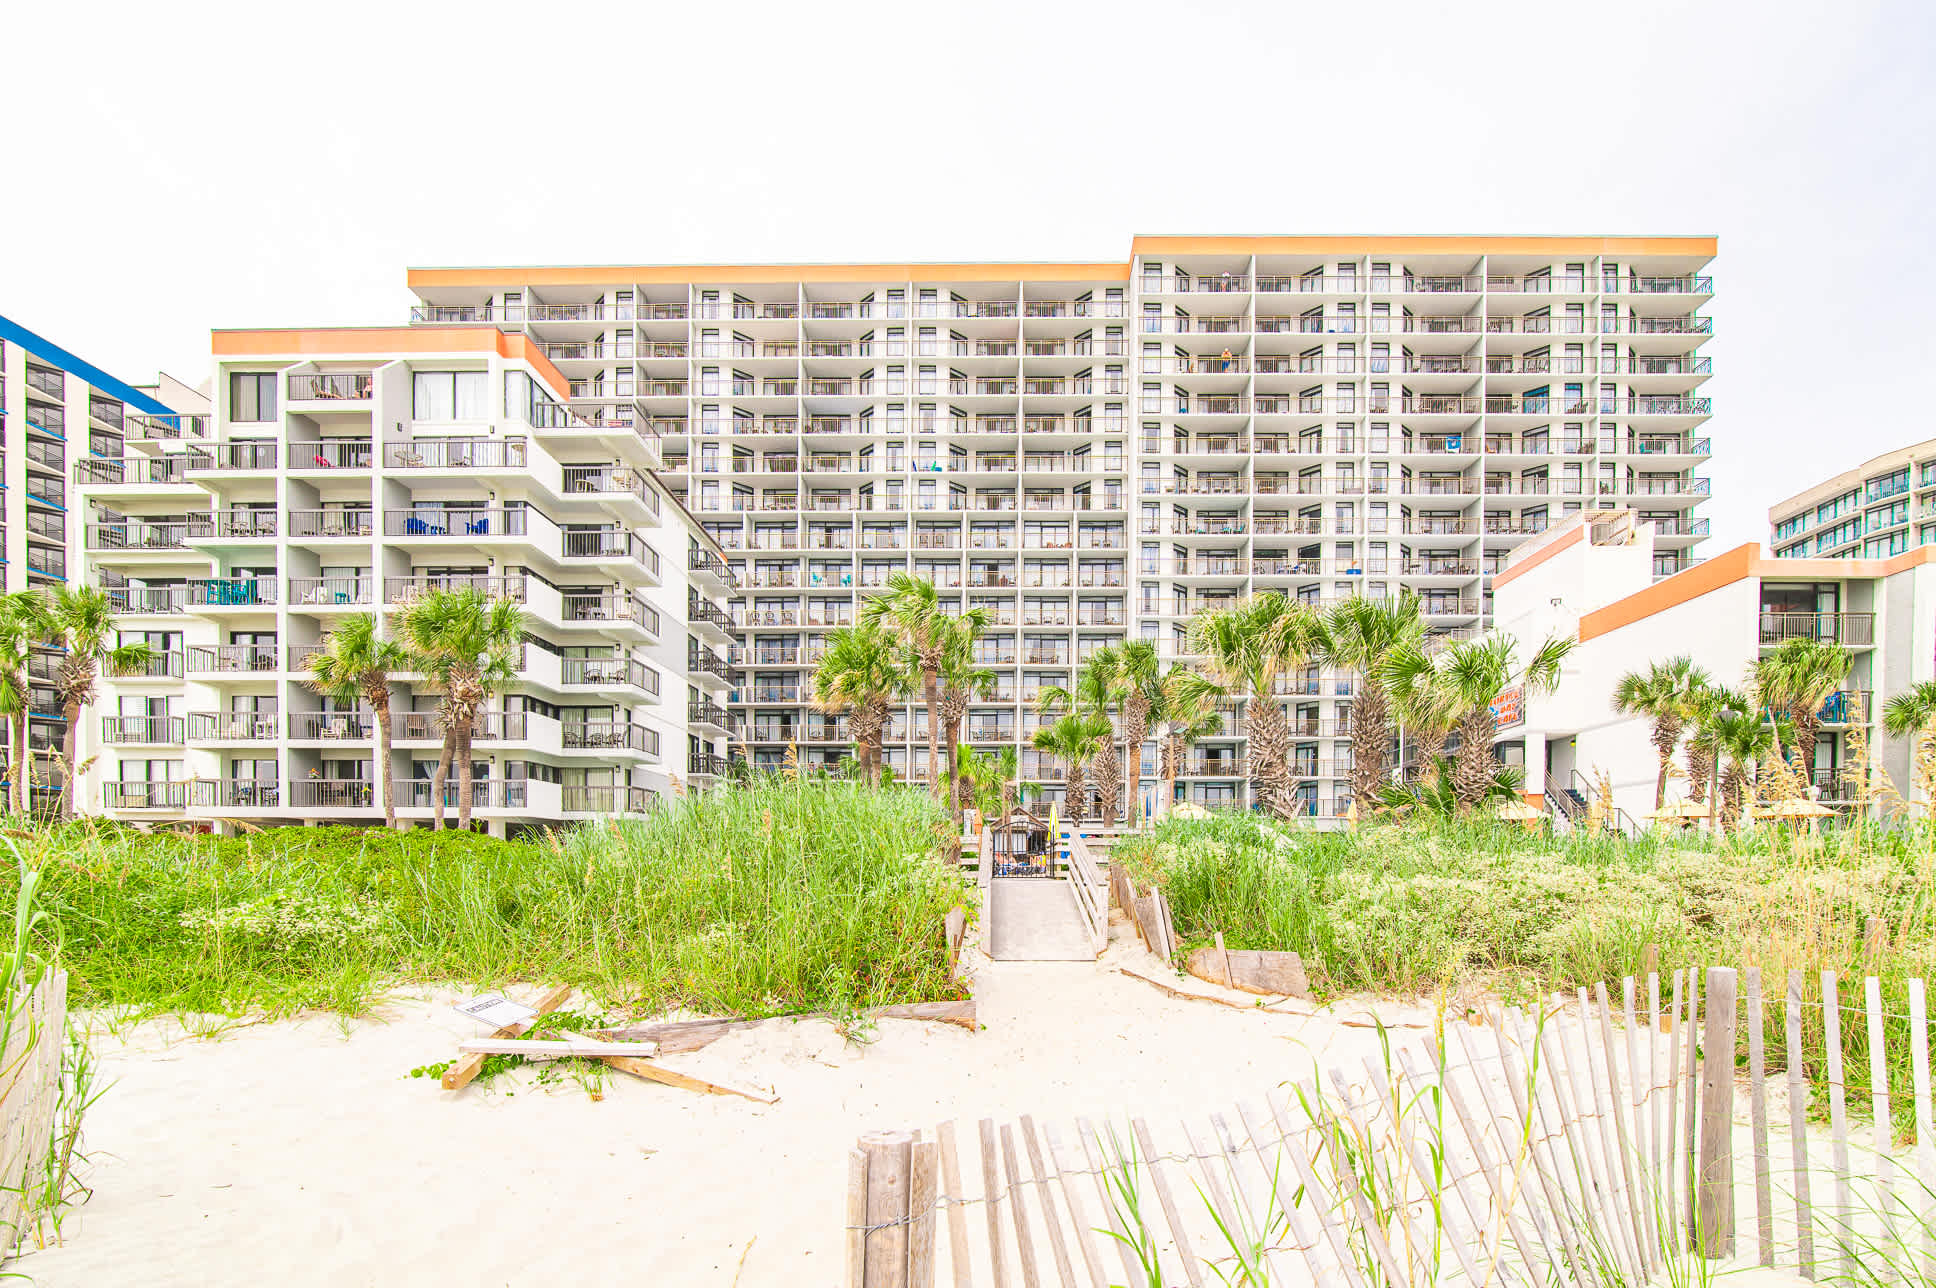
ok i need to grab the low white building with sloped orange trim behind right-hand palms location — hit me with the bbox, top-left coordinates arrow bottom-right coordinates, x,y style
1493,511 -> 1912,825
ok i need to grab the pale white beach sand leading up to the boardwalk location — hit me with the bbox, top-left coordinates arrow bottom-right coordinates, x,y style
14,924 -> 1427,1288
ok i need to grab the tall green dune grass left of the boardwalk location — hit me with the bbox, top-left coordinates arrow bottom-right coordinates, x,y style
23,781 -> 968,1017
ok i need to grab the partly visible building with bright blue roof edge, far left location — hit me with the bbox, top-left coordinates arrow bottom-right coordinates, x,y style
0,318 -> 201,786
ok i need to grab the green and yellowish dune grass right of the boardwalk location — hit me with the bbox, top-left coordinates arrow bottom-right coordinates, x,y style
1115,813 -> 1936,1127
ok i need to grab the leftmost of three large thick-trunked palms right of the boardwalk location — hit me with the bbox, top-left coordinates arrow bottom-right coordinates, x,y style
1189,591 -> 1320,819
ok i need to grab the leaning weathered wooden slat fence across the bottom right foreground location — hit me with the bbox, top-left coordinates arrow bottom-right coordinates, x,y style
846,968 -> 1936,1288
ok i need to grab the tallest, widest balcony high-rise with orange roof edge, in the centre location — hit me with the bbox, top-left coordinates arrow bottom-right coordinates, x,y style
410,236 -> 1715,815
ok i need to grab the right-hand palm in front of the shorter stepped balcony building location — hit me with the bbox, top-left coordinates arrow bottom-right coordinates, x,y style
403,585 -> 525,829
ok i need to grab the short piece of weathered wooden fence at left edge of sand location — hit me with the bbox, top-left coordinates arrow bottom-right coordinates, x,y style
0,970 -> 68,1261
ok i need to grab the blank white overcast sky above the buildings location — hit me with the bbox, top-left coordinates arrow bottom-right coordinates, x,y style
0,0 -> 1936,554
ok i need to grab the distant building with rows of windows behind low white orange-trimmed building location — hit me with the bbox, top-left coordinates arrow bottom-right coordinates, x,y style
1768,438 -> 1936,560
